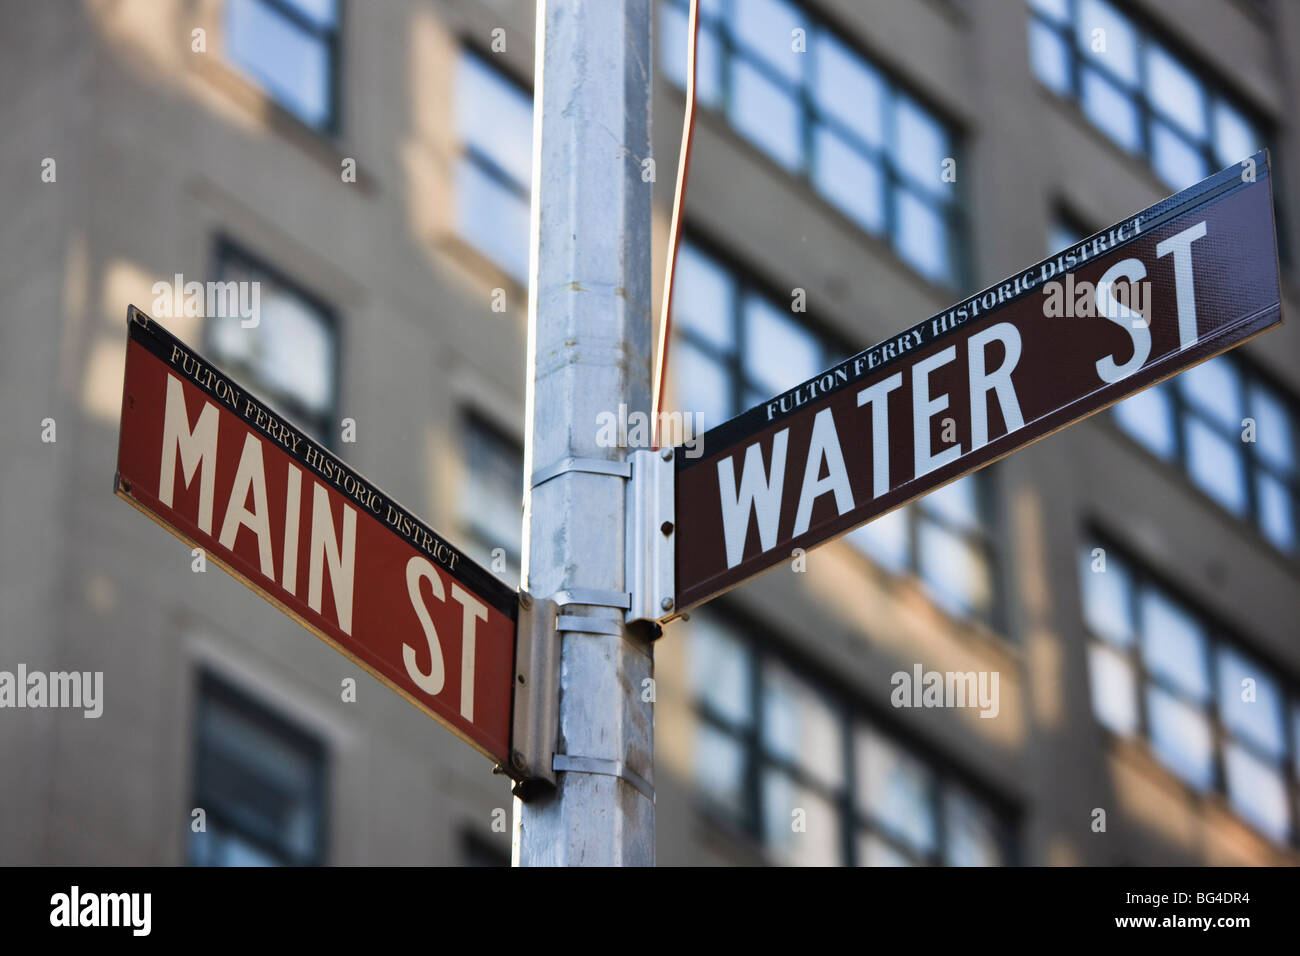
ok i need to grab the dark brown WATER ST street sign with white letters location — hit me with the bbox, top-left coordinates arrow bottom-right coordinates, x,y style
673,151 -> 1282,614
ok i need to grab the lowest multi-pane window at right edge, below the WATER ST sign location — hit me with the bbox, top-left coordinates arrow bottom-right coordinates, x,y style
1079,540 -> 1300,843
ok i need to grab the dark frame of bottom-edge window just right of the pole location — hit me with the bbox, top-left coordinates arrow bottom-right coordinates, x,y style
688,600 -> 1019,866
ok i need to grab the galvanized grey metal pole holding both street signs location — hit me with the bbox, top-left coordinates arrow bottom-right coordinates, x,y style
514,0 -> 654,866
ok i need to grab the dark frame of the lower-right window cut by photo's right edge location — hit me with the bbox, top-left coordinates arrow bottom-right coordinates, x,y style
1078,523 -> 1300,848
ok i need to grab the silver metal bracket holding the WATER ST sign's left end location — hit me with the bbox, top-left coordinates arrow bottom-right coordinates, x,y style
624,449 -> 677,623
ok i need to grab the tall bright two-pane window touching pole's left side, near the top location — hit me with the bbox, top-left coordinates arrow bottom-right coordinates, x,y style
456,51 -> 533,285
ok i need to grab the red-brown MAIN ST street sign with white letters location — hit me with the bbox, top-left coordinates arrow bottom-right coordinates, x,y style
116,307 -> 517,767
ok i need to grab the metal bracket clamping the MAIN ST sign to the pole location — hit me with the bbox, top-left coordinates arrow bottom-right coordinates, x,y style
503,591 -> 560,800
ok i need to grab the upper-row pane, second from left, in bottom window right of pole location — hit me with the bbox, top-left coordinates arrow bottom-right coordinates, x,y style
762,661 -> 844,787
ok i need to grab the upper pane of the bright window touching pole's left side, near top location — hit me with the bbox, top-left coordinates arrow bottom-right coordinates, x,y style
456,55 -> 533,188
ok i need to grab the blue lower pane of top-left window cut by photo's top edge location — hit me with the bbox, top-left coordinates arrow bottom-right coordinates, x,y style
226,0 -> 332,126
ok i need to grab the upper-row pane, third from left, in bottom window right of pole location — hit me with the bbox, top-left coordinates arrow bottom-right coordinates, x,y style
854,727 -> 936,853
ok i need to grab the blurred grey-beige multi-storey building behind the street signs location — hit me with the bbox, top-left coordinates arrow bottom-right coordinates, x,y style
0,0 -> 1300,865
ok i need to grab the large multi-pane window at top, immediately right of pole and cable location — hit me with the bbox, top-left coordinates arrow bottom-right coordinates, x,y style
659,0 -> 961,285
